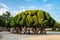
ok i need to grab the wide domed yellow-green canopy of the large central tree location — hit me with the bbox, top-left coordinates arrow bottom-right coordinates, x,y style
10,10 -> 55,28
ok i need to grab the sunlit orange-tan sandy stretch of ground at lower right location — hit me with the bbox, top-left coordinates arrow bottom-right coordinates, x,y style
19,35 -> 60,40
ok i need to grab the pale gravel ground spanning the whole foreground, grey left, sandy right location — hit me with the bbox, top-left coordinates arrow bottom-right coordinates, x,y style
0,32 -> 60,40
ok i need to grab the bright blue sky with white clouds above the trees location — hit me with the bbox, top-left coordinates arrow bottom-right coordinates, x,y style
0,0 -> 60,22
